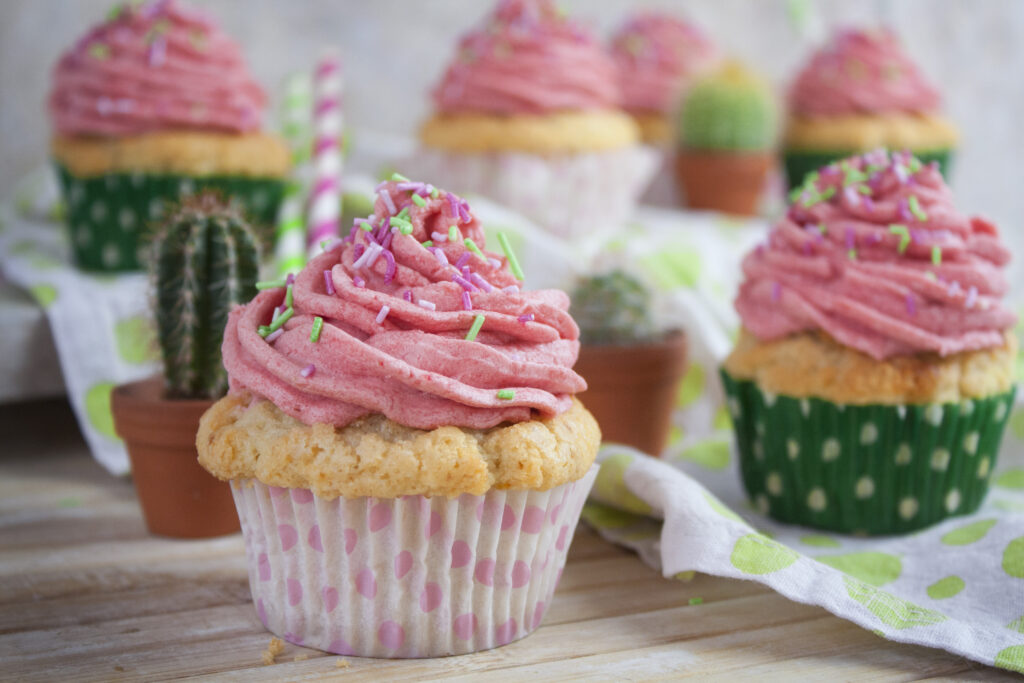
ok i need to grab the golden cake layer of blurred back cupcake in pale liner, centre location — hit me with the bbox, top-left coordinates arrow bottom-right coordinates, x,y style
420,110 -> 640,155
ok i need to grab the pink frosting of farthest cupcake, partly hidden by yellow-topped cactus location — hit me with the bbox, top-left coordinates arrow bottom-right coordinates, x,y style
611,12 -> 719,114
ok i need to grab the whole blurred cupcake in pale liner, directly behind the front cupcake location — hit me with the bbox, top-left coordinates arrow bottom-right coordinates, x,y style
399,0 -> 655,237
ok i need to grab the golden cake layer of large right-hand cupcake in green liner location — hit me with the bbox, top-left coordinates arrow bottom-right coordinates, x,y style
725,330 -> 1017,405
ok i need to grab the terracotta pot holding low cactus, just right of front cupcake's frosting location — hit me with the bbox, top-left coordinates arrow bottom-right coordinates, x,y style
574,332 -> 686,456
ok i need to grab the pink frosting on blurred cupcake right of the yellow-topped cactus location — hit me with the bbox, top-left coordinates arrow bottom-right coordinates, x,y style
790,29 -> 941,116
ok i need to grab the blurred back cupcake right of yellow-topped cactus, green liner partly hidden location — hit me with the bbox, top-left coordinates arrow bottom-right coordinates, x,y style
782,29 -> 957,189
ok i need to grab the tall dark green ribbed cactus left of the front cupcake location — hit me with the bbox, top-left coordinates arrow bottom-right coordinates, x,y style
150,193 -> 259,398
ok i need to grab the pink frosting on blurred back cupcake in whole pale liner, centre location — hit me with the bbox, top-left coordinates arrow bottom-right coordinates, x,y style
434,0 -> 620,114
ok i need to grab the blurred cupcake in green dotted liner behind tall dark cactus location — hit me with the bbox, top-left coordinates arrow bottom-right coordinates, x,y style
49,0 -> 288,270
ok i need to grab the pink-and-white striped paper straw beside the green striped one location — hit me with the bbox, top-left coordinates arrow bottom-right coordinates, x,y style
306,52 -> 342,255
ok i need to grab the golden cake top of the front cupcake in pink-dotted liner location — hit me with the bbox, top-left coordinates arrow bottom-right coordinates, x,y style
196,393 -> 601,500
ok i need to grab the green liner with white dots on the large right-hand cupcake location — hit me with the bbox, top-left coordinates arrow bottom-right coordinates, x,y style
722,371 -> 1016,536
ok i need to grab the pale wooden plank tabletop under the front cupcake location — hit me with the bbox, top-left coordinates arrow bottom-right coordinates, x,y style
0,402 -> 1020,681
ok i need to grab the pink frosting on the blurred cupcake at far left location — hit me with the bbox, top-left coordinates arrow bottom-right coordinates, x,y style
49,0 -> 266,136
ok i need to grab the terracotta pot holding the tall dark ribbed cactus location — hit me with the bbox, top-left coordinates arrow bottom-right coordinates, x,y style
111,377 -> 239,539
